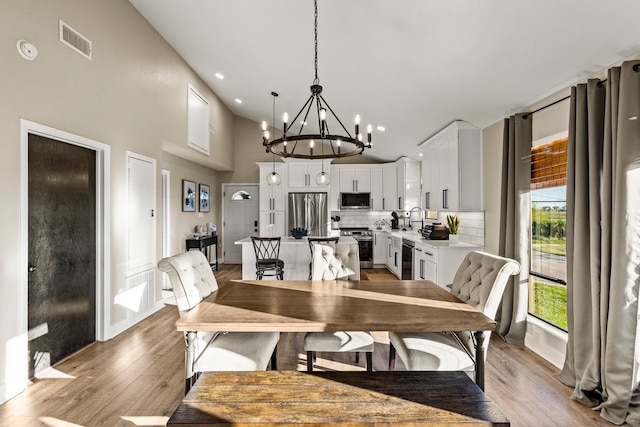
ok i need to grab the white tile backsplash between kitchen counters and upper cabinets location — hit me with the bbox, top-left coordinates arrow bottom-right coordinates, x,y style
331,210 -> 484,246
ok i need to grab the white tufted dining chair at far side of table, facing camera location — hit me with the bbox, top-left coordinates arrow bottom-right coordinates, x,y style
304,243 -> 373,372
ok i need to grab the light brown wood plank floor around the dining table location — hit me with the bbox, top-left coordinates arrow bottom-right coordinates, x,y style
0,265 -> 610,427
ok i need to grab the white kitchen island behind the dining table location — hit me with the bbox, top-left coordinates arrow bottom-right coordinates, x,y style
235,236 -> 357,280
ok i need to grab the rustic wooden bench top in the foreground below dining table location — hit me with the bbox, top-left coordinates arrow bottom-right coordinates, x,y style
167,371 -> 510,426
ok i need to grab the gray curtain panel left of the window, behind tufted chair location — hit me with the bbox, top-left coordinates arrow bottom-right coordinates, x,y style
496,113 -> 531,345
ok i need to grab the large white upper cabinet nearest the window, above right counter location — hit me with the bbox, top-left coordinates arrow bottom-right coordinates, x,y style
421,121 -> 482,211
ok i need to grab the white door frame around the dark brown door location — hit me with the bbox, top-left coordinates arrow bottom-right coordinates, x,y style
19,119 -> 111,376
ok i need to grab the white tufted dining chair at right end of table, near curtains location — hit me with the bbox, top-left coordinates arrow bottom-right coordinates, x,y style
389,251 -> 520,378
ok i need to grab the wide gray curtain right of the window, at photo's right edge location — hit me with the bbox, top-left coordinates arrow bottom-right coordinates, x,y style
558,61 -> 640,425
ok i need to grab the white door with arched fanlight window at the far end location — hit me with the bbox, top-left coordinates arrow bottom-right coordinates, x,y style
223,184 -> 259,264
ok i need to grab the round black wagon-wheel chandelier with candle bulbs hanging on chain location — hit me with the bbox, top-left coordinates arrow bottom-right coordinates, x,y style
262,0 -> 372,160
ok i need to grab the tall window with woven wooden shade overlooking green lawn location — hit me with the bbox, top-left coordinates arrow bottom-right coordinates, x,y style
529,135 -> 568,330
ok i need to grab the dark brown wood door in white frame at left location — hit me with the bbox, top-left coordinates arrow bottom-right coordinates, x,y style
28,134 -> 96,377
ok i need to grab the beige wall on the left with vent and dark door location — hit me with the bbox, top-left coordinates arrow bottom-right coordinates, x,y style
0,0 -> 235,402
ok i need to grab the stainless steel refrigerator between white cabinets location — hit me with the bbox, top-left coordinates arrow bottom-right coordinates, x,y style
287,193 -> 329,236
